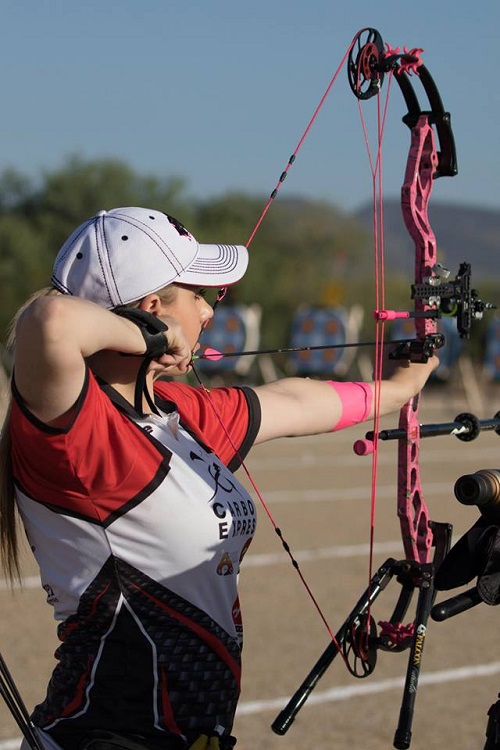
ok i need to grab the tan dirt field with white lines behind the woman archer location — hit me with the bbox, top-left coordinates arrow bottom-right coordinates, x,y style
0,392 -> 500,750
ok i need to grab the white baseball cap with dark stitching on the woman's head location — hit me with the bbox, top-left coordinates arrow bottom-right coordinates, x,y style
52,207 -> 248,309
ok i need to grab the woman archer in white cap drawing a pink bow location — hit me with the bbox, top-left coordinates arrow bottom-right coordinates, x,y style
0,208 -> 438,750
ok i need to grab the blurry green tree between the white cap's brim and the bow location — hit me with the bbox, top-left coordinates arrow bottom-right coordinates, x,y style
197,193 -> 369,346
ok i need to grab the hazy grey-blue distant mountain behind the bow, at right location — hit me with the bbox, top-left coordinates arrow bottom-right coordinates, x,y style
353,200 -> 500,284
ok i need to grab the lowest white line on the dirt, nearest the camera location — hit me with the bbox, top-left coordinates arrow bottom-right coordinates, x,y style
0,661 -> 500,750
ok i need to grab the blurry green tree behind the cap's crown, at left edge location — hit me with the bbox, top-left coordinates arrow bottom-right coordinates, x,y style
0,157 -> 192,339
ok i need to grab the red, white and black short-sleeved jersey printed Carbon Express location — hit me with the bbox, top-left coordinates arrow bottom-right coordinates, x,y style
10,372 -> 260,748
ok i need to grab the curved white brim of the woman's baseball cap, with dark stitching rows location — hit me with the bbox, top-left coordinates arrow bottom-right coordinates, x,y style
175,244 -> 248,287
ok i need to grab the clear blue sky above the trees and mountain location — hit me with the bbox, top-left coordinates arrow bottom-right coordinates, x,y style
0,0 -> 500,210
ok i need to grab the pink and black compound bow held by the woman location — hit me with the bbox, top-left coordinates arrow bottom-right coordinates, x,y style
272,28 -> 498,748
